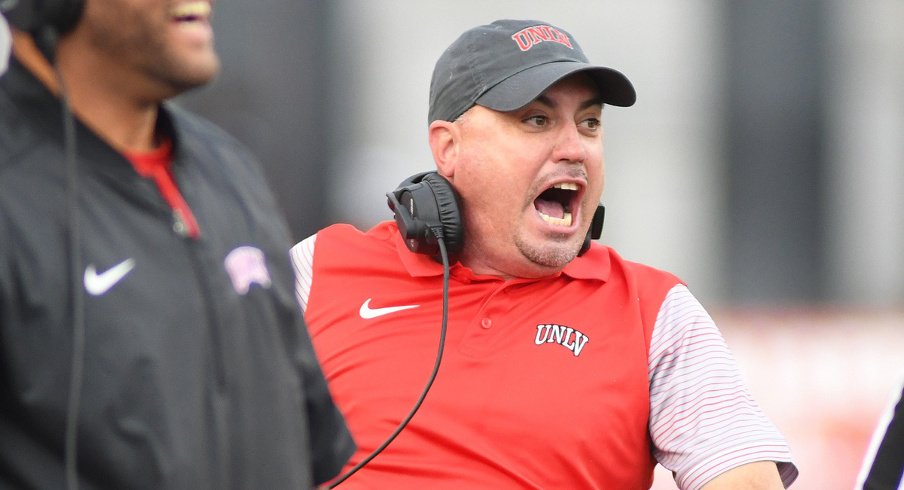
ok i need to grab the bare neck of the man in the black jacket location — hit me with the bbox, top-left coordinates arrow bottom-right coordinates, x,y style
13,31 -> 159,152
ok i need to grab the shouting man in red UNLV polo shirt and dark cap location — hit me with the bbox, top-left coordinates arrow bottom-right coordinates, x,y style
292,20 -> 797,489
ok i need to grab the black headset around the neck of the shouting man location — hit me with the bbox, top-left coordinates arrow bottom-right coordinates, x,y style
386,172 -> 606,263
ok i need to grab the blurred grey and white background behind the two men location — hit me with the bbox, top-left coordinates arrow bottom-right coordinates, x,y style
173,0 -> 904,490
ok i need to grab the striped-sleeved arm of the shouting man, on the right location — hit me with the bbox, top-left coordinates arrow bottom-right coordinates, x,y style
650,285 -> 798,489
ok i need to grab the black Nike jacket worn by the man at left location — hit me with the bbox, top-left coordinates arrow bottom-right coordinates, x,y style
0,61 -> 354,489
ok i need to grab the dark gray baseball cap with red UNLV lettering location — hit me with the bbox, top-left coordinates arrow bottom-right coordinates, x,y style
428,19 -> 637,122
